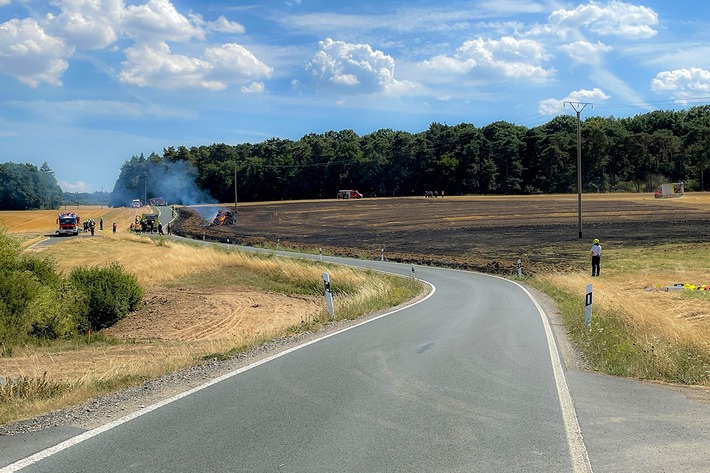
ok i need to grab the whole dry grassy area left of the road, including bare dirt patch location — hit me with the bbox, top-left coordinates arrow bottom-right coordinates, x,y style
0,230 -> 416,423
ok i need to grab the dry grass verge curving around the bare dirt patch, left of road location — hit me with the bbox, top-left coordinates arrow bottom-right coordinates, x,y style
0,235 -> 424,424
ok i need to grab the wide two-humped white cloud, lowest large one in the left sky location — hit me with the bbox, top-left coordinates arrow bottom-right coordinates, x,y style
119,42 -> 271,90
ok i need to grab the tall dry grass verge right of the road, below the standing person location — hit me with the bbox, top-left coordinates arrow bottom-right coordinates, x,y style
536,243 -> 710,385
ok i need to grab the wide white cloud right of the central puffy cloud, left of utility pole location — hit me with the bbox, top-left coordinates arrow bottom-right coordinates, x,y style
420,36 -> 555,80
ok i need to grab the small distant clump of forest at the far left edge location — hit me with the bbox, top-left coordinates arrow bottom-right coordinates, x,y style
0,162 -> 62,210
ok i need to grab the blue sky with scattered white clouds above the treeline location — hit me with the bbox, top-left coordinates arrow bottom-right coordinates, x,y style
0,0 -> 710,192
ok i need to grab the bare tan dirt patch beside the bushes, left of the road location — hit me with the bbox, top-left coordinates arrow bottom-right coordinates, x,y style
0,287 -> 322,381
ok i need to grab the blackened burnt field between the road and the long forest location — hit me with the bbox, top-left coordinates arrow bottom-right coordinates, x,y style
172,194 -> 710,273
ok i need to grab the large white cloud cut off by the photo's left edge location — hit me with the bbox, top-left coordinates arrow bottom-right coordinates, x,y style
0,18 -> 73,87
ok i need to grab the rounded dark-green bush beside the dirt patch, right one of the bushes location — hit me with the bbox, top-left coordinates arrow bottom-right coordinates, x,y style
69,262 -> 143,330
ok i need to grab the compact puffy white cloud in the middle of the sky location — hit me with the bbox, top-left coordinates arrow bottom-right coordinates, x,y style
306,38 -> 417,94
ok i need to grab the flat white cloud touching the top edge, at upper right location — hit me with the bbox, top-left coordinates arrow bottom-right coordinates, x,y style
549,0 -> 658,39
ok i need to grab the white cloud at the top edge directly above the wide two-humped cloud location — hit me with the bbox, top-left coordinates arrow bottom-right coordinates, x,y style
123,0 -> 205,42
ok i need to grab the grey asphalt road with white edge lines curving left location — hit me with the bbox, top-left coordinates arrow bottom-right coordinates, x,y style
0,245 -> 710,472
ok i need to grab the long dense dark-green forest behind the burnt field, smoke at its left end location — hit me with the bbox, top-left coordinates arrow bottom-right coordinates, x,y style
112,106 -> 710,205
